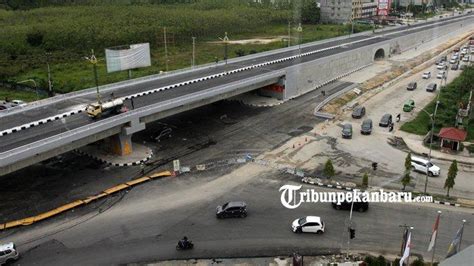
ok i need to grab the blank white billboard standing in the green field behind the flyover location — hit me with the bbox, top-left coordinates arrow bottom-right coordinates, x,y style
105,43 -> 151,73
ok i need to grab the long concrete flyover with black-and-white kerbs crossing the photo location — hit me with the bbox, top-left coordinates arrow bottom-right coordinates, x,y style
0,15 -> 474,175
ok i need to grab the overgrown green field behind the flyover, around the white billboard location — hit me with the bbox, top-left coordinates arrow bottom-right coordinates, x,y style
0,2 -> 371,99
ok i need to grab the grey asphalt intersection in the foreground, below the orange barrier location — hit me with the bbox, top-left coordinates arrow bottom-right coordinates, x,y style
6,169 -> 474,265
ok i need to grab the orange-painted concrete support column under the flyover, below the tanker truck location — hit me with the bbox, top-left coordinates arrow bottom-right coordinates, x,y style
107,118 -> 145,156
